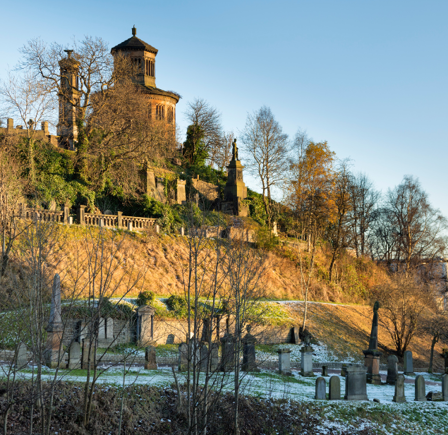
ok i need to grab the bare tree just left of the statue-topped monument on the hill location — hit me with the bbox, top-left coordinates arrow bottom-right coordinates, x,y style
185,98 -> 222,167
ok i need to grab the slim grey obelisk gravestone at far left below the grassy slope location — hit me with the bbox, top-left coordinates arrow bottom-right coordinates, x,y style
44,273 -> 64,368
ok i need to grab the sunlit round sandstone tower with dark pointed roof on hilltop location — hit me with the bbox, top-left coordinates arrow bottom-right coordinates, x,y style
111,26 -> 180,127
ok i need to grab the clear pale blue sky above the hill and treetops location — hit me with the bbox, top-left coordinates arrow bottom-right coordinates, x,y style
0,0 -> 448,216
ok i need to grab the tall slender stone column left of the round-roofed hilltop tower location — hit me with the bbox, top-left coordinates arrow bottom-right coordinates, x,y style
57,50 -> 80,150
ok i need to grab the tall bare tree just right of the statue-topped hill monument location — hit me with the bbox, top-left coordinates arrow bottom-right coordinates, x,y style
242,106 -> 289,227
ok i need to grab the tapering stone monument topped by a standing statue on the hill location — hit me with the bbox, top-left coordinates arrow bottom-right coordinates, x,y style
222,139 -> 249,216
